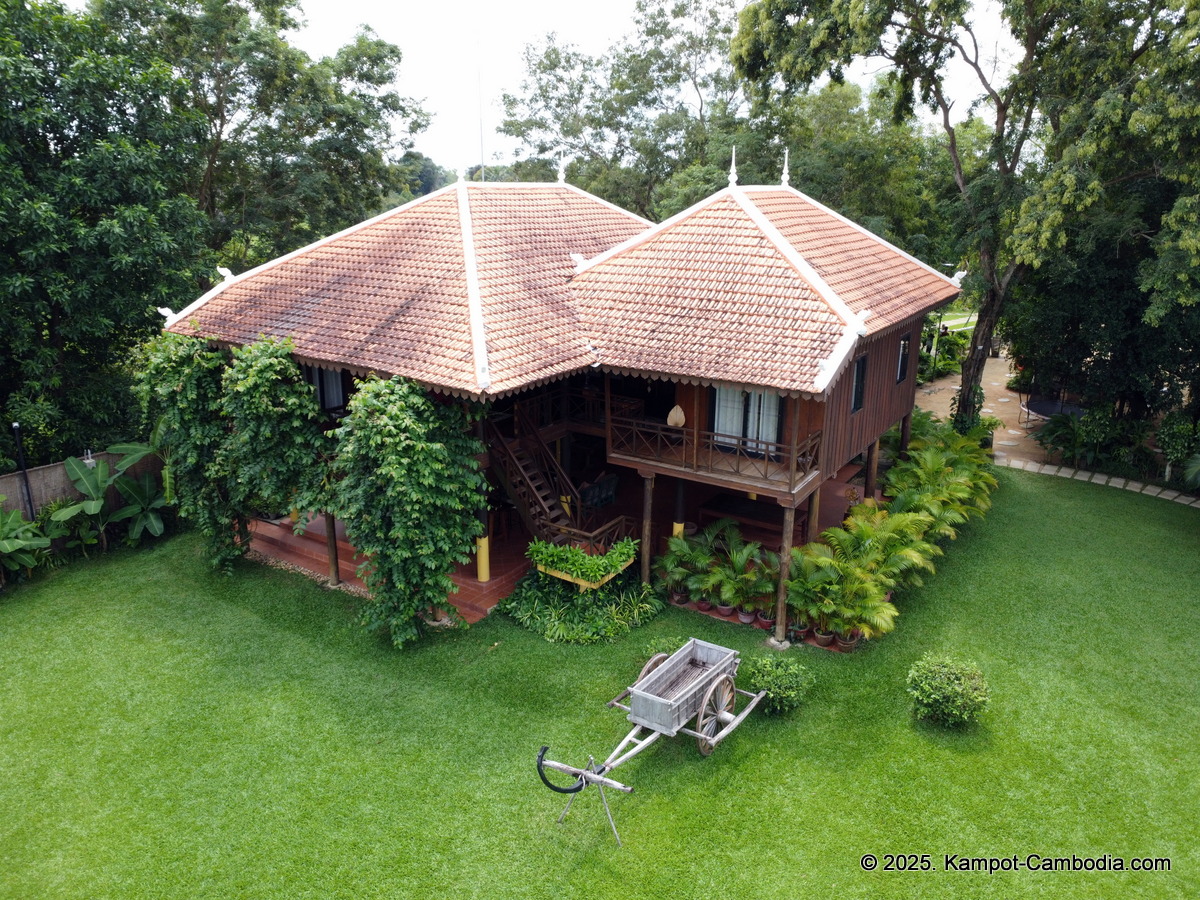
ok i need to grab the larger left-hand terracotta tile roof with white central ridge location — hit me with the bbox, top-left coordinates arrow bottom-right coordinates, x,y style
169,184 -> 649,396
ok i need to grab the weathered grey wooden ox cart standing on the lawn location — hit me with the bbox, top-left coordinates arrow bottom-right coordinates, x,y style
538,637 -> 766,845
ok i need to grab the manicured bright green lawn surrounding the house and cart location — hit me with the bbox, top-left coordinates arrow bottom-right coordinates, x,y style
0,473 -> 1200,899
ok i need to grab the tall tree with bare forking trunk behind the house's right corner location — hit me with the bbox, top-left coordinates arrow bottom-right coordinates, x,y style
733,0 -> 1194,427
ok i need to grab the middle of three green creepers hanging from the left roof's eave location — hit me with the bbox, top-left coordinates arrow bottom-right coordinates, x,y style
221,338 -> 334,514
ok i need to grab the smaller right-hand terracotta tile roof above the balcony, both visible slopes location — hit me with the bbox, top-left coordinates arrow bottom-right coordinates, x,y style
572,187 -> 958,395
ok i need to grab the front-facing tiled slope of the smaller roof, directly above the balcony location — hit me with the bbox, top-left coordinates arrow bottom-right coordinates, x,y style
571,192 -> 846,392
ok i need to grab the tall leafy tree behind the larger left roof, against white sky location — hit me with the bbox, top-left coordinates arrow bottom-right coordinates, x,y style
94,0 -> 428,269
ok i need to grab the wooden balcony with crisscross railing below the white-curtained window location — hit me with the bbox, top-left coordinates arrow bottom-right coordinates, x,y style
608,414 -> 821,498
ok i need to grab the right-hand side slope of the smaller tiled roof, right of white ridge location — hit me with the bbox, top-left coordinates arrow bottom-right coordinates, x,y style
744,187 -> 959,334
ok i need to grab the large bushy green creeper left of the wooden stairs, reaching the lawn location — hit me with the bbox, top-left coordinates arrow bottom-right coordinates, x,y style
332,378 -> 486,647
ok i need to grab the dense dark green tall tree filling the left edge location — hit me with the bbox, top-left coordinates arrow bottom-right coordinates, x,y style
0,0 -> 203,463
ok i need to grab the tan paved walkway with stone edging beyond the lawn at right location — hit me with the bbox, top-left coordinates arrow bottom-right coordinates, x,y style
917,356 -> 1200,509
